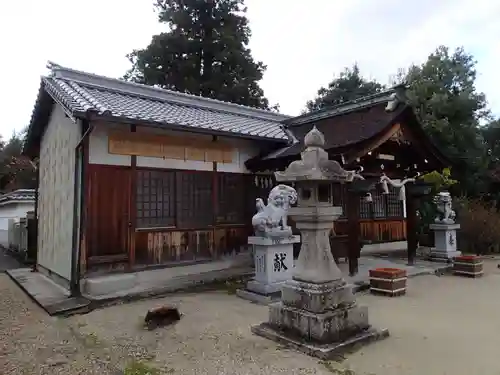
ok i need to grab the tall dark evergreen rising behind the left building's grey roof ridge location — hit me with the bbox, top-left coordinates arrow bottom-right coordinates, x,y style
124,0 -> 269,109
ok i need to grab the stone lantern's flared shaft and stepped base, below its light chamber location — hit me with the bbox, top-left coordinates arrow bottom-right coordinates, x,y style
252,205 -> 389,359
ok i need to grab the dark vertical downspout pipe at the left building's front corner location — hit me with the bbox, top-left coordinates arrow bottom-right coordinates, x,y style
70,120 -> 94,297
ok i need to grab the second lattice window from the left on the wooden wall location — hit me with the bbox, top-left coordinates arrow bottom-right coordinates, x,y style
176,171 -> 214,229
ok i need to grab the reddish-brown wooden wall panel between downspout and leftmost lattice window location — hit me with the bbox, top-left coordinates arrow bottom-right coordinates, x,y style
85,164 -> 131,264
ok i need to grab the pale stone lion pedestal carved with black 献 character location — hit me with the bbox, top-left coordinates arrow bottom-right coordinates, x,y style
236,235 -> 300,304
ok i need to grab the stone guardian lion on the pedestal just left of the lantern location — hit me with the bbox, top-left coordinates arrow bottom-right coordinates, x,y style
252,184 -> 297,237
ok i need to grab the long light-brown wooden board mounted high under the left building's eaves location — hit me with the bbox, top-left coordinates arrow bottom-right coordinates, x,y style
108,131 -> 233,163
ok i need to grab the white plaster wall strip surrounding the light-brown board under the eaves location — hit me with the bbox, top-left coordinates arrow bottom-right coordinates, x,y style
89,123 -> 259,173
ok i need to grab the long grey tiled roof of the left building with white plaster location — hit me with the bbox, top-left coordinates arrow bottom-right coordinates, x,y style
30,63 -> 291,142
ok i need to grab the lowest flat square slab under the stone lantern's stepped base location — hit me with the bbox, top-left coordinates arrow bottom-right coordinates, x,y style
251,323 -> 389,360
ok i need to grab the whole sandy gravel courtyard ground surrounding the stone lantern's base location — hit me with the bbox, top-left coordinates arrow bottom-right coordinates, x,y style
0,261 -> 500,375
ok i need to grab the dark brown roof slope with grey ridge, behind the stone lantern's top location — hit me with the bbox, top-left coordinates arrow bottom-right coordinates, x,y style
263,90 -> 406,159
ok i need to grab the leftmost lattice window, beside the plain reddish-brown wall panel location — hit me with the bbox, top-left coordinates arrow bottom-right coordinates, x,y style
136,171 -> 175,228
